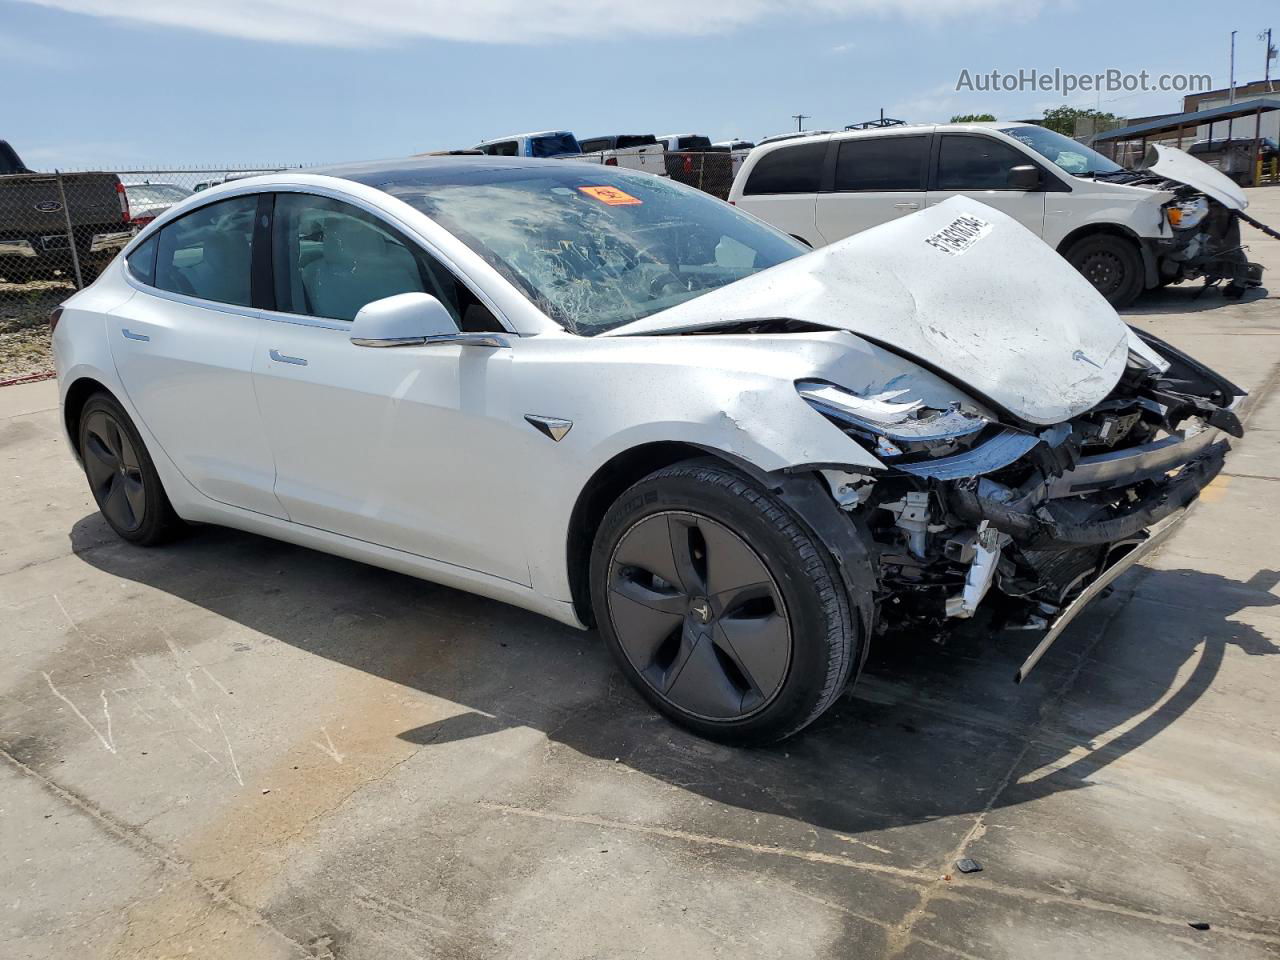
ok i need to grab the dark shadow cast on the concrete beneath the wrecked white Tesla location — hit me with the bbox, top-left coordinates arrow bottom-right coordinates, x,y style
70,513 -> 1280,833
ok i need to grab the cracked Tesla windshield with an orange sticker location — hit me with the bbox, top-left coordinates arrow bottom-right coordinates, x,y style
390,165 -> 805,337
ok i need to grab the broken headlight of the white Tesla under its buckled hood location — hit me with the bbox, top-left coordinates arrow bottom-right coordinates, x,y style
796,380 -> 992,460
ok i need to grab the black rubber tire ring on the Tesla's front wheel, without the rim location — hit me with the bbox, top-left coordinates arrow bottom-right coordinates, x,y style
590,465 -> 860,744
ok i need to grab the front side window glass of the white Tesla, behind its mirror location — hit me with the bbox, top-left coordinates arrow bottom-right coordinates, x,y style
271,193 -> 502,332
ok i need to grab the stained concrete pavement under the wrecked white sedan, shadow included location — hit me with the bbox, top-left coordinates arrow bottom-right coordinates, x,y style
0,189 -> 1280,960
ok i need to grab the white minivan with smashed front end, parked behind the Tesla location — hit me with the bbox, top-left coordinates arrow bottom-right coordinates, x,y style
730,123 -> 1262,307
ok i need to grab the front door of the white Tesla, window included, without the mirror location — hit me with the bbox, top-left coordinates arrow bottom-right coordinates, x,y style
253,193 -> 529,584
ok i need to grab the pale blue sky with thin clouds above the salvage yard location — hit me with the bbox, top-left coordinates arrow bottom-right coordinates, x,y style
0,0 -> 1280,169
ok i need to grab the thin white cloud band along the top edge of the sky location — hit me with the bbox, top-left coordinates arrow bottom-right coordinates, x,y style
12,0 -> 1039,46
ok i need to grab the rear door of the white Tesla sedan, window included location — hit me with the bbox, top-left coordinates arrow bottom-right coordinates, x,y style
108,193 -> 285,518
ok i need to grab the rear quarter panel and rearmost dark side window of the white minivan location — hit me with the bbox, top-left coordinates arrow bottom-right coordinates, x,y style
737,137 -> 828,247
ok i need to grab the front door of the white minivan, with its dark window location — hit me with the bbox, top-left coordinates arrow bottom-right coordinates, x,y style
928,133 -> 1060,237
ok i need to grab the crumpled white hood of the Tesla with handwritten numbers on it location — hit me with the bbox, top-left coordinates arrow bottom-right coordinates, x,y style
603,197 -> 1129,424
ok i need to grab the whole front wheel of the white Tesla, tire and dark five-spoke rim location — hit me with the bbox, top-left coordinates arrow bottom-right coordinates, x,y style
590,460 -> 863,745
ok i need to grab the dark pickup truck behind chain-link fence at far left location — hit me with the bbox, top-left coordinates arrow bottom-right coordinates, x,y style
0,140 -> 133,284
